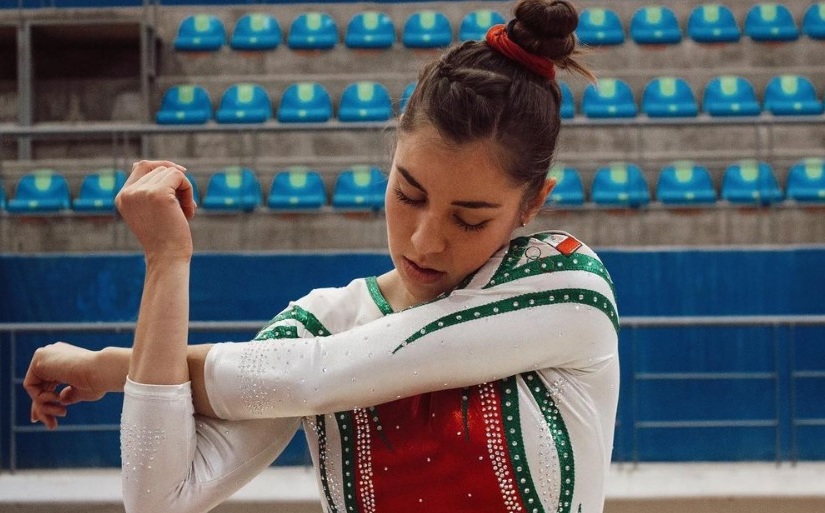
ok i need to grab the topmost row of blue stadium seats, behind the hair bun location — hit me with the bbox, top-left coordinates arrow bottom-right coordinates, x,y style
169,2 -> 825,52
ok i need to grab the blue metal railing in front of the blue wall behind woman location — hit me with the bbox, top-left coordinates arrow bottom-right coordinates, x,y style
0,315 -> 825,471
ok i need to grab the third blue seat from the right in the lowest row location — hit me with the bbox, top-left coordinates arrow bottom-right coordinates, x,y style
656,160 -> 716,205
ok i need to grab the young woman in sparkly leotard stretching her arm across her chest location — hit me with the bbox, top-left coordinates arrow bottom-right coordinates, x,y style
26,0 -> 619,513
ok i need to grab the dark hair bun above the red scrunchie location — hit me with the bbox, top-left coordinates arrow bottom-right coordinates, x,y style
509,0 -> 579,64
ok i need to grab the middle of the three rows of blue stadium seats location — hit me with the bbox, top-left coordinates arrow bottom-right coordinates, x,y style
155,75 -> 825,125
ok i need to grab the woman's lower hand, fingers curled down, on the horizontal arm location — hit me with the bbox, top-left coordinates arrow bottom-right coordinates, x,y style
23,342 -> 108,429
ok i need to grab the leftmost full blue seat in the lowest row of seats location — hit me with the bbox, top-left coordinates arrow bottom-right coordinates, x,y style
6,169 -> 71,214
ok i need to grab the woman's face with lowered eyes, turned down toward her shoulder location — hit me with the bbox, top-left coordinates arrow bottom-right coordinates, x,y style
386,125 -> 524,306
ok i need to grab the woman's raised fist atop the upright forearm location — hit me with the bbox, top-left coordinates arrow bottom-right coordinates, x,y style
115,160 -> 196,259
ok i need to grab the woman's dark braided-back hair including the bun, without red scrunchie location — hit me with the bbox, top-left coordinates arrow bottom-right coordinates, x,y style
398,0 -> 594,206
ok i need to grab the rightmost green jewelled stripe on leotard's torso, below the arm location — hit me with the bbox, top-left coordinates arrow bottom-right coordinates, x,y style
522,372 -> 576,513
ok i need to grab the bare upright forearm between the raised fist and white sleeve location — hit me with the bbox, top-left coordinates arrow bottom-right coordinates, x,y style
129,257 -> 190,385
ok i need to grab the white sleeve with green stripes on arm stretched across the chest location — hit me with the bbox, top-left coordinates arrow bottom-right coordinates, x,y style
205,238 -> 618,419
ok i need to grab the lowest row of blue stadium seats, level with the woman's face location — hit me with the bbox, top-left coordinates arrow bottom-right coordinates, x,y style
0,158 -> 825,214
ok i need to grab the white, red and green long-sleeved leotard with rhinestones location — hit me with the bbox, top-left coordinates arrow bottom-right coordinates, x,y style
122,232 -> 619,513
